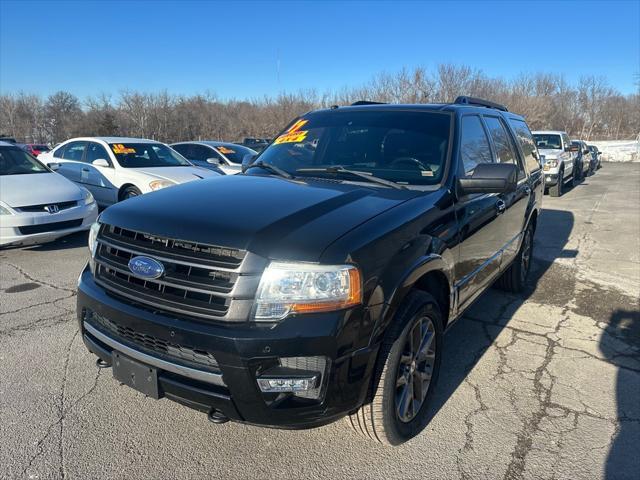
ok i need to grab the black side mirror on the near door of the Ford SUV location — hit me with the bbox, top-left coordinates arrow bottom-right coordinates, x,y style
458,163 -> 518,196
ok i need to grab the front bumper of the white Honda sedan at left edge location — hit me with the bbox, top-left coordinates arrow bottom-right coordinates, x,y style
0,202 -> 98,246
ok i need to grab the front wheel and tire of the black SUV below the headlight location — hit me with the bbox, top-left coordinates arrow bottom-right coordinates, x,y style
346,290 -> 443,445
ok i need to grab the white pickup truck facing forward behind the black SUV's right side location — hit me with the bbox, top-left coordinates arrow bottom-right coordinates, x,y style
531,130 -> 581,197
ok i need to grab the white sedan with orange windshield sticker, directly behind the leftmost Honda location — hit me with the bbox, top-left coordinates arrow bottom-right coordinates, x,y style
38,137 -> 218,207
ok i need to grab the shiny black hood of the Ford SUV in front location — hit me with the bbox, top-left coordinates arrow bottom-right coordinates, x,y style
100,175 -> 420,261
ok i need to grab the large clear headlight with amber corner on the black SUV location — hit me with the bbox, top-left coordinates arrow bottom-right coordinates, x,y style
254,262 -> 362,321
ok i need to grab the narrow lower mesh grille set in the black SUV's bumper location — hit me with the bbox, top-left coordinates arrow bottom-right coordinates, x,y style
85,312 -> 220,372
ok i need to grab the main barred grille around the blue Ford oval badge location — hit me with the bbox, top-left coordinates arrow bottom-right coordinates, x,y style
94,225 -> 259,320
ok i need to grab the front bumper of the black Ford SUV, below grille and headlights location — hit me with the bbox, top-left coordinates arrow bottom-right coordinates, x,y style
77,268 -> 378,428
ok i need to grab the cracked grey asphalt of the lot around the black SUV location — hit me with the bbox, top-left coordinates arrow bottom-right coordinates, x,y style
0,164 -> 640,479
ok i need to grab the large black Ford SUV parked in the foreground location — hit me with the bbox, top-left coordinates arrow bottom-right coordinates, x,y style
78,97 -> 544,445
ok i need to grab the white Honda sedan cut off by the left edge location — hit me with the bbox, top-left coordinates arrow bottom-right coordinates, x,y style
0,142 -> 98,246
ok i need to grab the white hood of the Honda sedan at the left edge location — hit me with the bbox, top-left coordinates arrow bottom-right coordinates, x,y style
0,172 -> 83,207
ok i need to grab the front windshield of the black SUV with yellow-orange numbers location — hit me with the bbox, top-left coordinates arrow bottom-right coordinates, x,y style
259,110 -> 451,185
